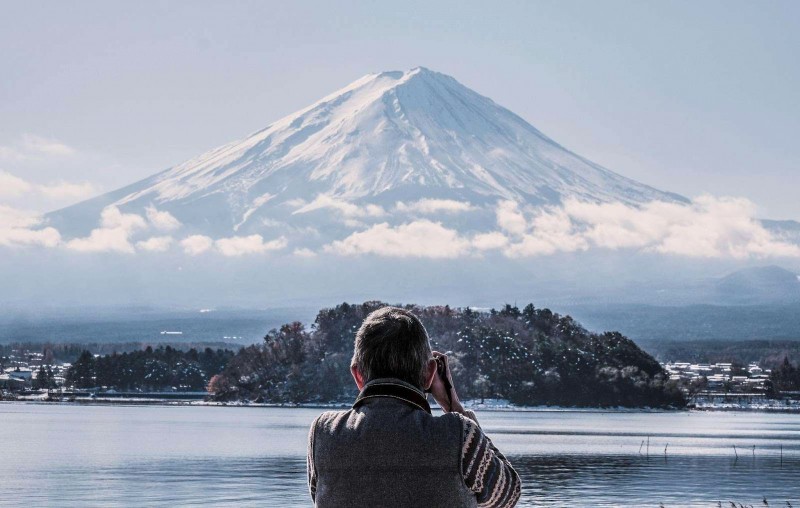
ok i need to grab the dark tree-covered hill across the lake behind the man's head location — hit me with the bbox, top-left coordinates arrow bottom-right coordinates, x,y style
209,302 -> 686,407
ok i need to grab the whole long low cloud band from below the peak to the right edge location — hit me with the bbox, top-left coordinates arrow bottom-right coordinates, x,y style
324,196 -> 800,259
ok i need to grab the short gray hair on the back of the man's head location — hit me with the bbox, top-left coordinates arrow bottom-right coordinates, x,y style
351,307 -> 432,389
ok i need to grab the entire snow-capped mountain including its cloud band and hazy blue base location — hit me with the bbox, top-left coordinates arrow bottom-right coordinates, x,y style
6,67 -> 800,308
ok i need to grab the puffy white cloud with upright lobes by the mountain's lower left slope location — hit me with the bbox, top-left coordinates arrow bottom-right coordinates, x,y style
66,206 -> 147,254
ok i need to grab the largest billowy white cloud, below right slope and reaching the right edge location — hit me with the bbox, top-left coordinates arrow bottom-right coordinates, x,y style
496,196 -> 800,259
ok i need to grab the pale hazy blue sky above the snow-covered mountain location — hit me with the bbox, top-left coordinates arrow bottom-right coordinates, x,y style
0,1 -> 800,219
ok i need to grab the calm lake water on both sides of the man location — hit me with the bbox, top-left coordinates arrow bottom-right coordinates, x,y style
0,403 -> 800,507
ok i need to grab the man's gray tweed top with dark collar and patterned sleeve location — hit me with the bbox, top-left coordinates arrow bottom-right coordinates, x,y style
307,379 -> 520,508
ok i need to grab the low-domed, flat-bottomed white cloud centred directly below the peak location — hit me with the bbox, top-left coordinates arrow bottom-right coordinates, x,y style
324,220 -> 470,259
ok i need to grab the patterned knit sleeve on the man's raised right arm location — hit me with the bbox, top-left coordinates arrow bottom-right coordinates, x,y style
461,412 -> 521,508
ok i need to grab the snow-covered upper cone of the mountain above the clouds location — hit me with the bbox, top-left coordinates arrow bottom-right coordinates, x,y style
46,67 -> 686,237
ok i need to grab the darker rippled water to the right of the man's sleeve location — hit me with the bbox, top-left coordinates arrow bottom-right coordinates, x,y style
513,455 -> 800,507
